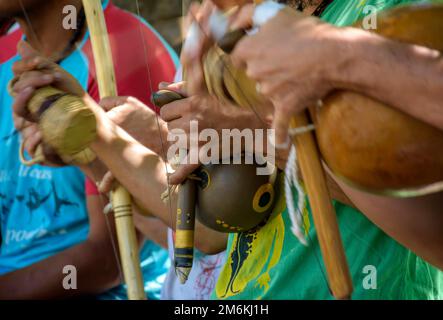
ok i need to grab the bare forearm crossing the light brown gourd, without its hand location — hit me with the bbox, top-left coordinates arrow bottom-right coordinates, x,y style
335,28 -> 443,130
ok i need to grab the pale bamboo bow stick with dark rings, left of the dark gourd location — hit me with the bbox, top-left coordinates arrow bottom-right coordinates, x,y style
83,0 -> 146,300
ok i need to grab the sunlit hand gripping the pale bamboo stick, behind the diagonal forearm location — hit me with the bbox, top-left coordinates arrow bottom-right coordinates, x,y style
100,97 -> 168,159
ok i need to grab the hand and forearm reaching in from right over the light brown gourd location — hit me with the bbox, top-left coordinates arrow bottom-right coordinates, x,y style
231,5 -> 443,145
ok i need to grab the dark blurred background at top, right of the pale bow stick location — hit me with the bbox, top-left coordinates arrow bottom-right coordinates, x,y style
112,0 -> 192,53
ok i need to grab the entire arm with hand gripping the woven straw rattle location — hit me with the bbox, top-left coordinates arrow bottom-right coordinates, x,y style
8,42 -> 226,253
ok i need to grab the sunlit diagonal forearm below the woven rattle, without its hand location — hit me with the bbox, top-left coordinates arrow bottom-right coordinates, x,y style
86,106 -> 227,254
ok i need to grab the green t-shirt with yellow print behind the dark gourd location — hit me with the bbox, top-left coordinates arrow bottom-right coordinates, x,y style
212,0 -> 443,299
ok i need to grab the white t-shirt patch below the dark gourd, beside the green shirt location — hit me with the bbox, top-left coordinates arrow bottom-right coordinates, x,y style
161,229 -> 226,300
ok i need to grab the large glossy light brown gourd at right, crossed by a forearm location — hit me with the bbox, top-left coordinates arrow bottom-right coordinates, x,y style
315,4 -> 443,197
